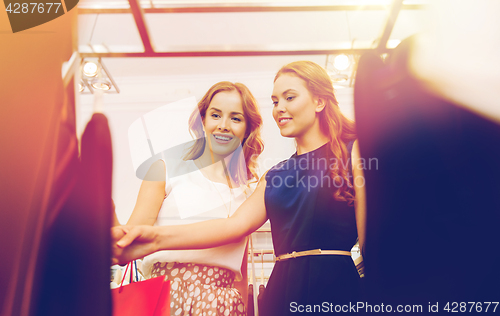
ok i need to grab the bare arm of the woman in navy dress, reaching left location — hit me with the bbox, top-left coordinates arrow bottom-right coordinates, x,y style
112,176 -> 267,263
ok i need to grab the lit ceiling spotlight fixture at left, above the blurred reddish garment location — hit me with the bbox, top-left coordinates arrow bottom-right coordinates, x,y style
78,58 -> 120,94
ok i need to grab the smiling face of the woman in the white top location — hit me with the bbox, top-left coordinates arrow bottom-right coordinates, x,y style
203,90 -> 247,156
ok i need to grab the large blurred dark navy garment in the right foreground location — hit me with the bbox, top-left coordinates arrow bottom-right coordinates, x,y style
354,40 -> 500,309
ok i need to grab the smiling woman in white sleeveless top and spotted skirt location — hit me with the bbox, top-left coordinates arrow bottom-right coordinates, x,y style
127,81 -> 263,315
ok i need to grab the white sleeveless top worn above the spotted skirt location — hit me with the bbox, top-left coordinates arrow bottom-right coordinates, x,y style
143,160 -> 250,280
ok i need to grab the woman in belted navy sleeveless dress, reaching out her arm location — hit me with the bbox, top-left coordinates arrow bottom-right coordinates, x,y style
112,61 -> 366,315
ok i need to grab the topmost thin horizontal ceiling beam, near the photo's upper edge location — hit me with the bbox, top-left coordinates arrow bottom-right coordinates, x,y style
78,0 -> 425,14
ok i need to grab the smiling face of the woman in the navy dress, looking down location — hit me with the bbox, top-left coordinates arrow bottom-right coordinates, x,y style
271,73 -> 324,138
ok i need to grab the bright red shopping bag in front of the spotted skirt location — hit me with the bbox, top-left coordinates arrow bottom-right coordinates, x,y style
111,263 -> 170,316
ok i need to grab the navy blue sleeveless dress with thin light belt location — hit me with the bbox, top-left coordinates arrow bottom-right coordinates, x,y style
261,142 -> 359,316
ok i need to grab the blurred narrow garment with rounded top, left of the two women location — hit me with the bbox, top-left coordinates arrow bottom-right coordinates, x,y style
32,113 -> 112,316
